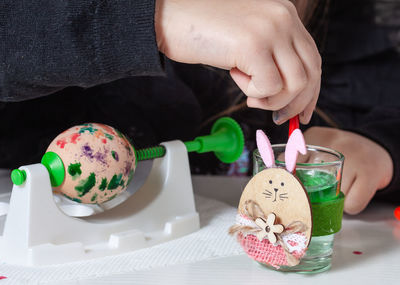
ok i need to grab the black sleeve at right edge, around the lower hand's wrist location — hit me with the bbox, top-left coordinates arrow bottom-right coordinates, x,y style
352,106 -> 400,202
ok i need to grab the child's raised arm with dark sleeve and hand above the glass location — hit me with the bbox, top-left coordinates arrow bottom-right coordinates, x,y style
0,0 -> 321,124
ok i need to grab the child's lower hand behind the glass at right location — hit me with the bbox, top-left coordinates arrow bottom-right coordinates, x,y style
304,127 -> 393,214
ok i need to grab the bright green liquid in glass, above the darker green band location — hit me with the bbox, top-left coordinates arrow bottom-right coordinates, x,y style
296,168 -> 338,203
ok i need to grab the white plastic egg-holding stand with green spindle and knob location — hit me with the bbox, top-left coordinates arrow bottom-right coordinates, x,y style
0,118 -> 244,266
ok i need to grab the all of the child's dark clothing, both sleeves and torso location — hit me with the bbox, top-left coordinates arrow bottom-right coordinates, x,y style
0,0 -> 400,201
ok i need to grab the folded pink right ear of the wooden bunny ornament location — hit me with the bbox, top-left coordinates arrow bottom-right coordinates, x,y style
285,129 -> 307,172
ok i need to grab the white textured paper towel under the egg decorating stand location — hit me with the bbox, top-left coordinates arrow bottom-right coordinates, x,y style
0,196 -> 243,284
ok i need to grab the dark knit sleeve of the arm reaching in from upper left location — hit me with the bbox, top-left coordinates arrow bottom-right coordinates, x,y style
0,0 -> 163,101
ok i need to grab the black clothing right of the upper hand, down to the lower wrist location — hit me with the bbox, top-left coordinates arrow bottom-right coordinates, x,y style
318,0 -> 400,201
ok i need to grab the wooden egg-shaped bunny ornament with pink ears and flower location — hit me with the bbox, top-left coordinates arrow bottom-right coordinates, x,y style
230,129 -> 312,269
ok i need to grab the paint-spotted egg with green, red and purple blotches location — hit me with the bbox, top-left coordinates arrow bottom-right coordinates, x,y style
47,123 -> 136,204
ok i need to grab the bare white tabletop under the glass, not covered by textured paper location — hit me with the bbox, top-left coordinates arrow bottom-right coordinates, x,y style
54,176 -> 400,285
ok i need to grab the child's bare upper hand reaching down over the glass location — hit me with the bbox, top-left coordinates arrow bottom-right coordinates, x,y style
155,0 -> 321,124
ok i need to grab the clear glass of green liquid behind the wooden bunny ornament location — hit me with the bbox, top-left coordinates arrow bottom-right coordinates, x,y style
253,144 -> 344,273
